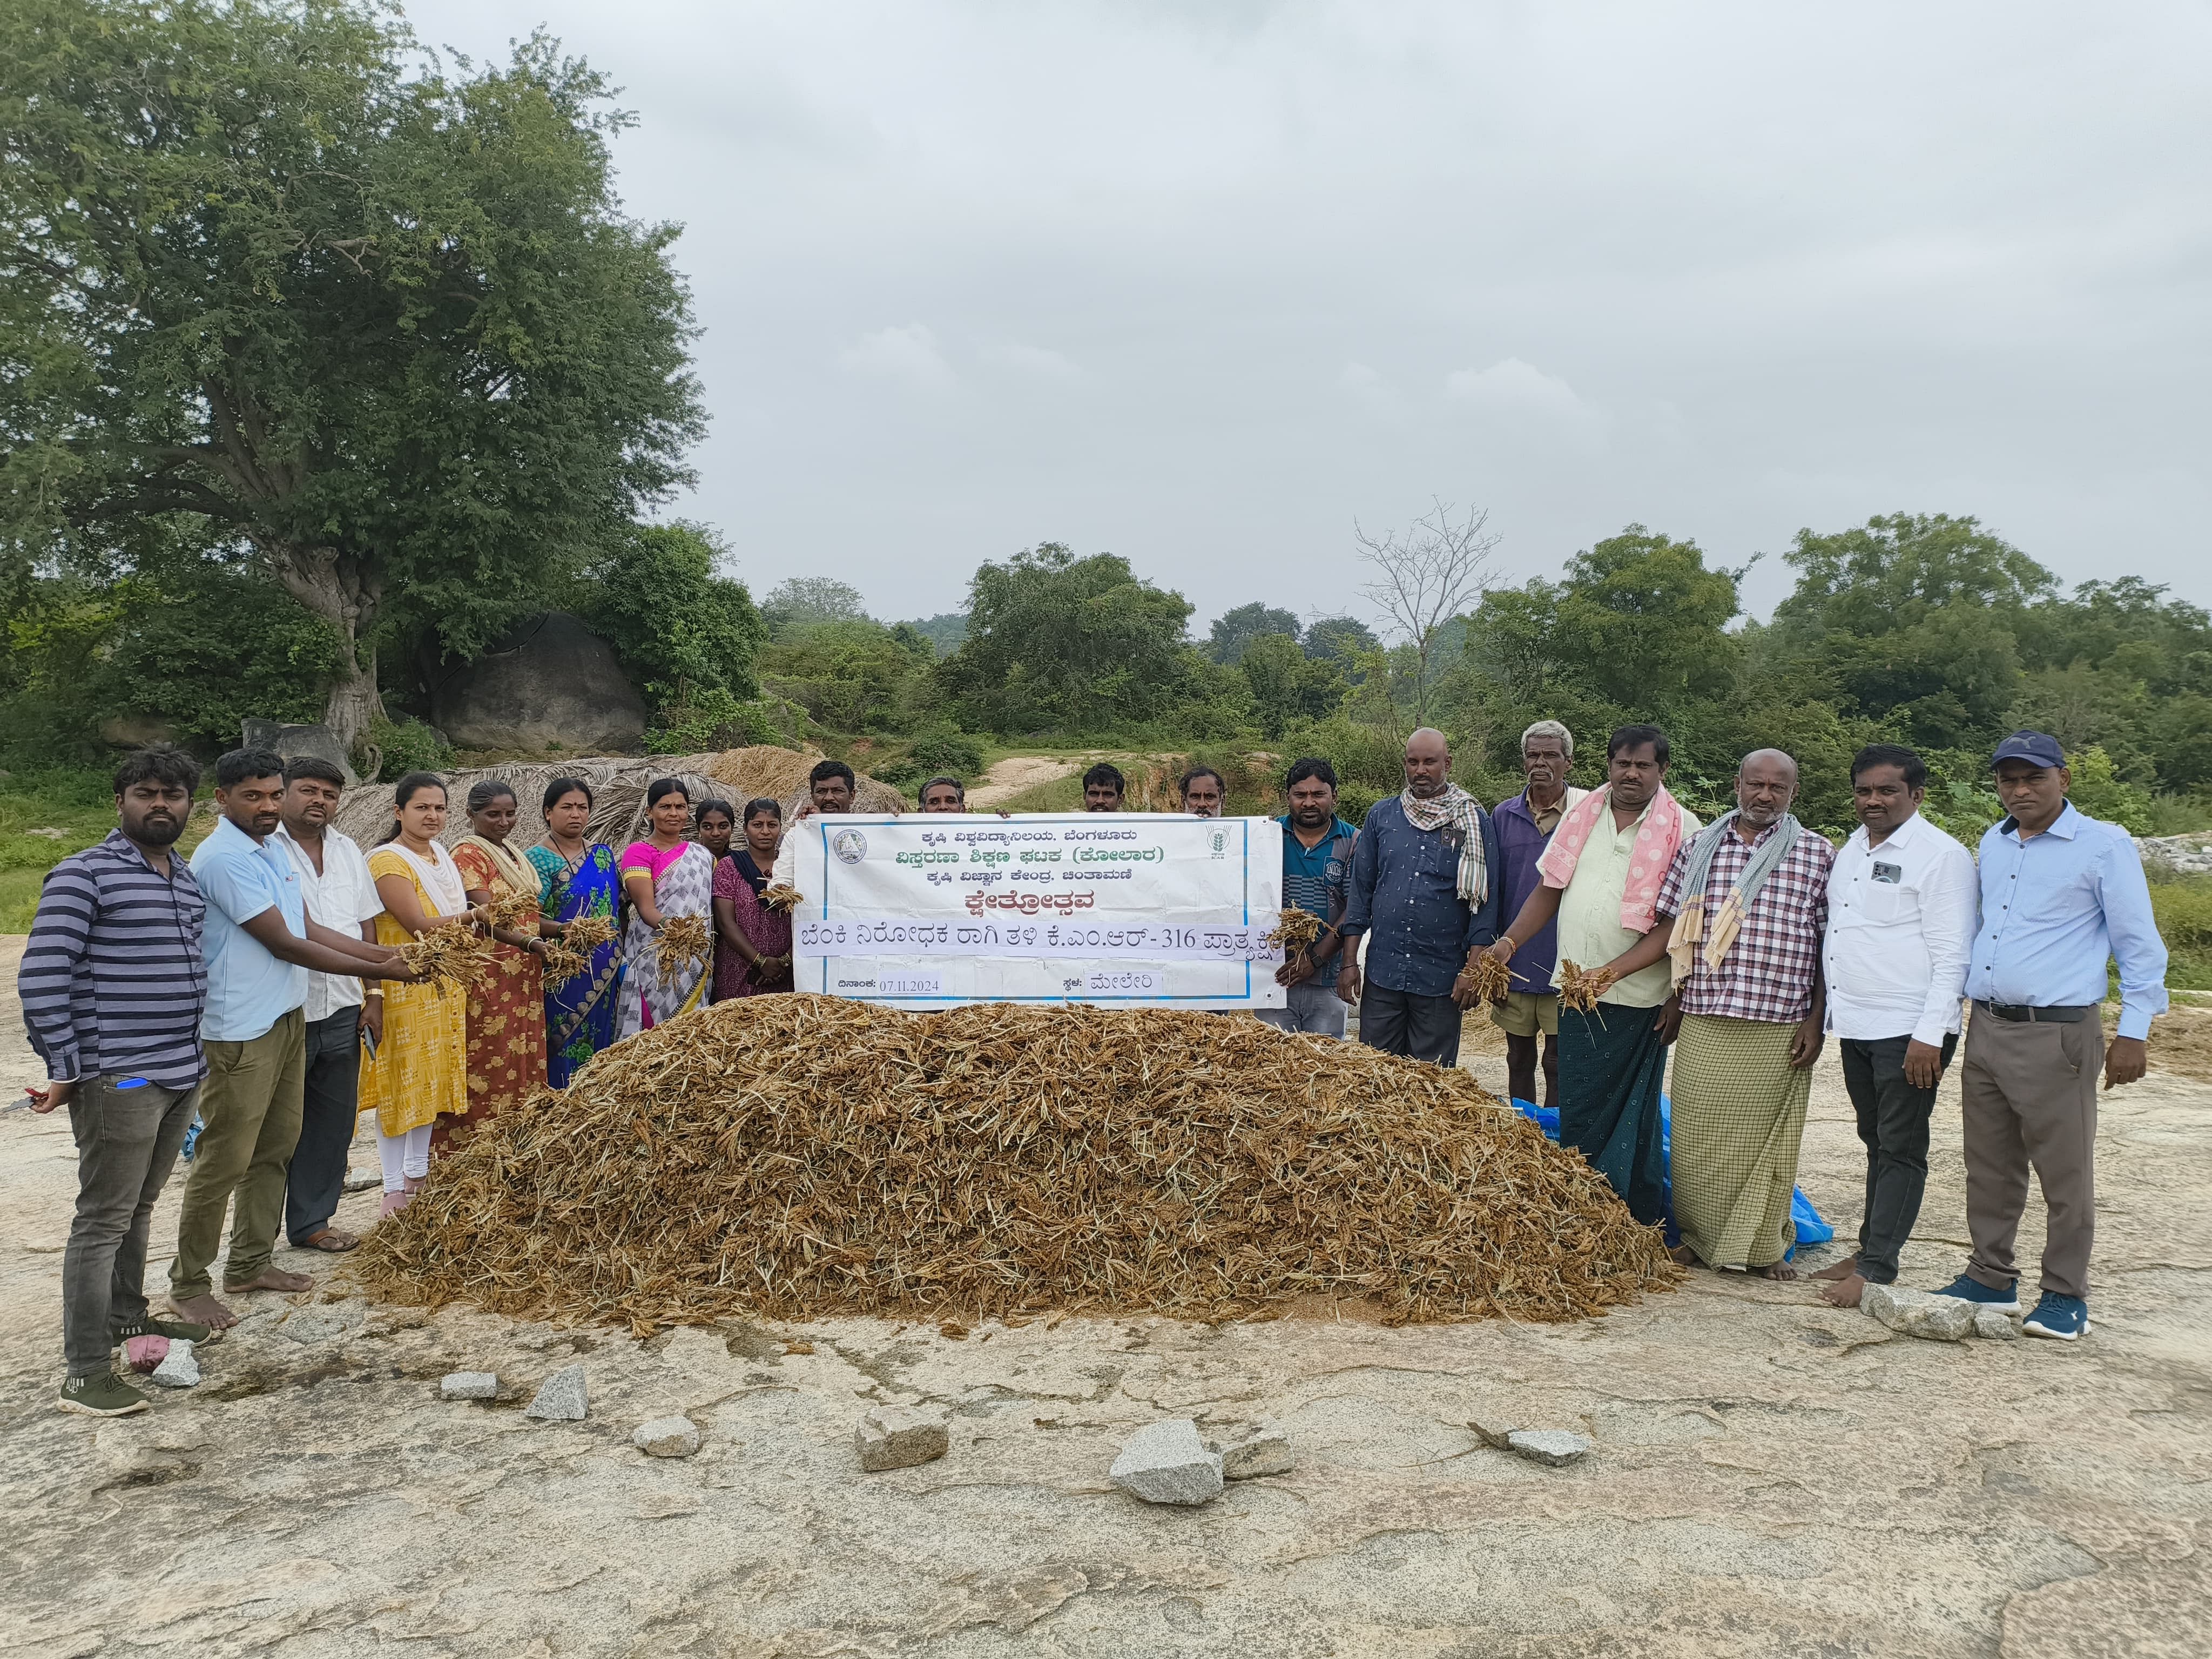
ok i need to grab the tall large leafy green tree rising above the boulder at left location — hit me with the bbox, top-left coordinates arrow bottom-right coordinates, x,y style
0,0 -> 701,739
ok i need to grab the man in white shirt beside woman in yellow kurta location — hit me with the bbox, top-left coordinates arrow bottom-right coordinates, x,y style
272,754 -> 385,1252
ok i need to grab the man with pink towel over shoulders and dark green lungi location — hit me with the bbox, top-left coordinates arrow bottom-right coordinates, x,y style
1491,725 -> 1699,1225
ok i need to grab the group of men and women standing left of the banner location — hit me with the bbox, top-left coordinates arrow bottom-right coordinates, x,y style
20,747 -> 854,1415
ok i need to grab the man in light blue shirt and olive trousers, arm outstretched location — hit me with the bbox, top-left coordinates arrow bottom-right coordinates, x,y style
168,750 -> 407,1332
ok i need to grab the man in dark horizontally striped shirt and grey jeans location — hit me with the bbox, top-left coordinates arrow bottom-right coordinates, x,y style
18,747 -> 214,1418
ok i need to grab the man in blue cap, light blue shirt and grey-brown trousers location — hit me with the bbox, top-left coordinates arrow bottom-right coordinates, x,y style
1942,732 -> 2166,1343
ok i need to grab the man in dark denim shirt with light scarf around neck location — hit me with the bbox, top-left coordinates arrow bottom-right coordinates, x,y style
1336,725 -> 1498,1066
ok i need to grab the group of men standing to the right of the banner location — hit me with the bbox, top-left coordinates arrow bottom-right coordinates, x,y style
1272,721 -> 2166,1340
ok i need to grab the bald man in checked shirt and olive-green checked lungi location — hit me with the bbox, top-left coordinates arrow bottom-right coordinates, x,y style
1606,750 -> 1836,1278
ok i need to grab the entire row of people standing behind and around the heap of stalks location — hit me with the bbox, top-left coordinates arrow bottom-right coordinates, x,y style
20,721 -> 2166,1415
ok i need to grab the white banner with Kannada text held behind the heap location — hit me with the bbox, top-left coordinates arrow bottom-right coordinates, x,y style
790,812 -> 1283,1009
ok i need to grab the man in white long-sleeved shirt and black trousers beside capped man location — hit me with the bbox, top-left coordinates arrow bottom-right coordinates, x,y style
1814,743 -> 1978,1307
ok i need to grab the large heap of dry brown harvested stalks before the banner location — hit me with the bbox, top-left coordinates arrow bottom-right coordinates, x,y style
359,995 -> 1681,1330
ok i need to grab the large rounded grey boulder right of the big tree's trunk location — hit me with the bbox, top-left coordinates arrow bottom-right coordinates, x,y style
431,610 -> 646,754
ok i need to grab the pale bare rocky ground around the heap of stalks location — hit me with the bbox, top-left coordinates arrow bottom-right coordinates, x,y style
0,942 -> 2212,1659
